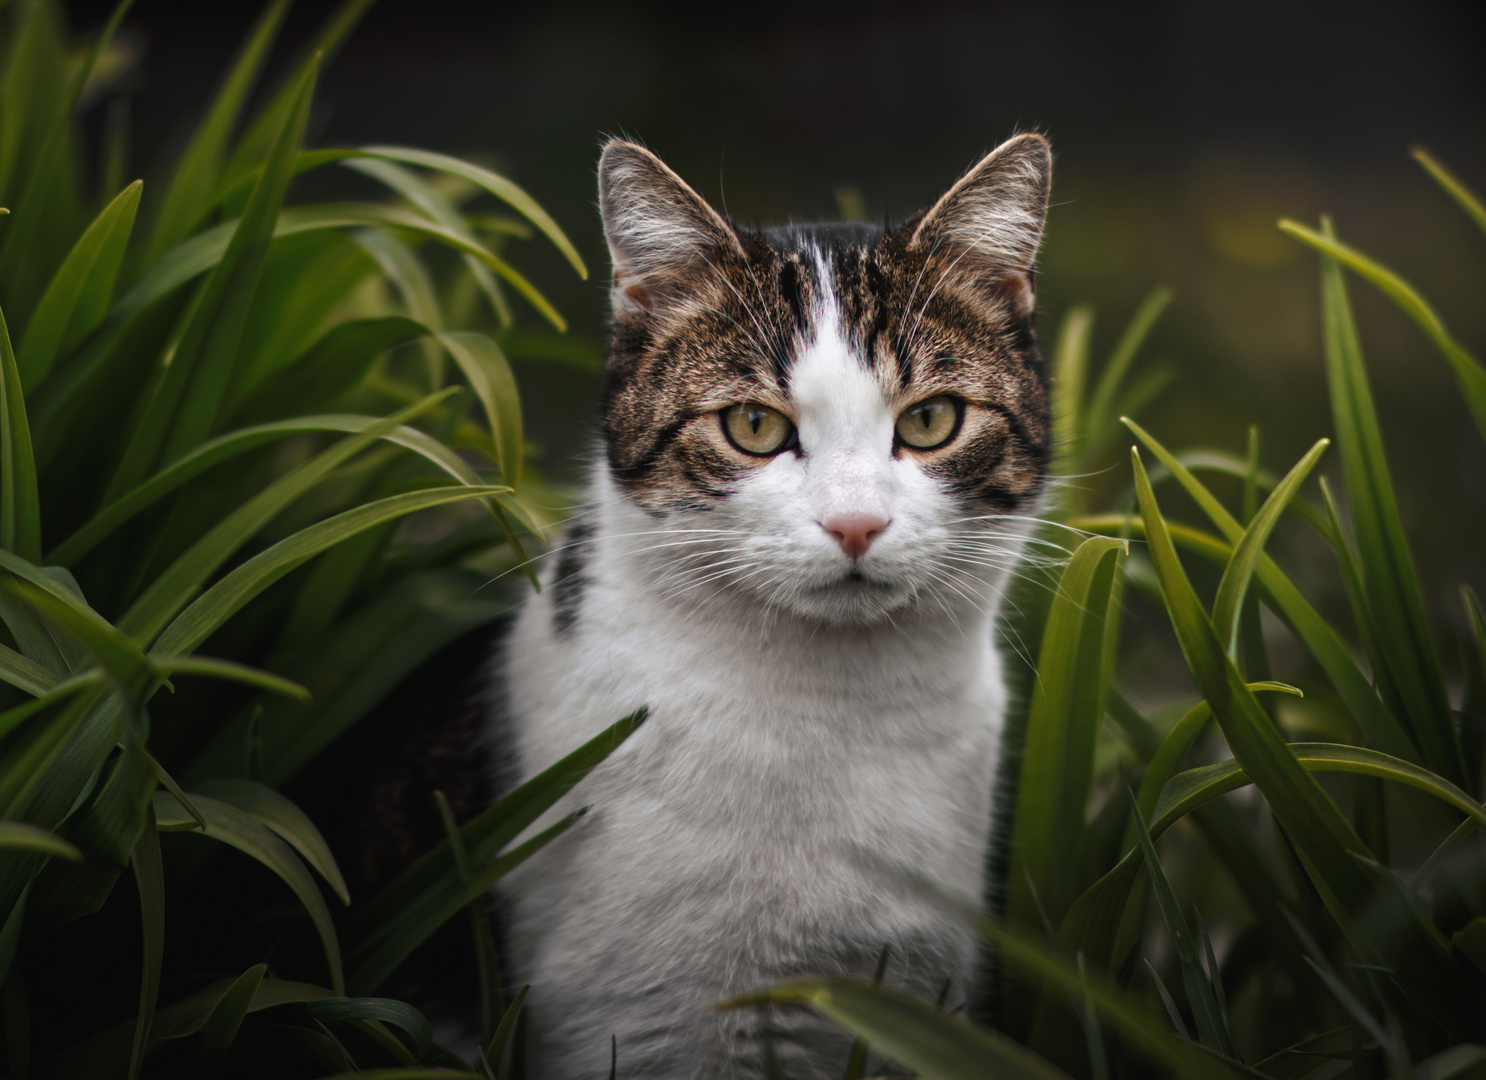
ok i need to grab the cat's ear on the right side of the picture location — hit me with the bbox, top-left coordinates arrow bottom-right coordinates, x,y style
908,132 -> 1052,312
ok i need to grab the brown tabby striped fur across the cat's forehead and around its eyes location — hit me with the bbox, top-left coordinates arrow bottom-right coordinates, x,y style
605,221 -> 1049,511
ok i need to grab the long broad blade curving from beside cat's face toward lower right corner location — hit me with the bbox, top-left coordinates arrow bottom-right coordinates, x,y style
1131,450 -> 1486,1038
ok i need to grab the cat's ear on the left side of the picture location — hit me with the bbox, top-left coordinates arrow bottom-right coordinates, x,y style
599,140 -> 743,316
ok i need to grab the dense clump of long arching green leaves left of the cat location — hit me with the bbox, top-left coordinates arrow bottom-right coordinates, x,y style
0,0 -> 642,1080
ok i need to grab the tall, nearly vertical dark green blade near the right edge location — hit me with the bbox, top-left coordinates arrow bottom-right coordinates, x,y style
1321,224 -> 1462,783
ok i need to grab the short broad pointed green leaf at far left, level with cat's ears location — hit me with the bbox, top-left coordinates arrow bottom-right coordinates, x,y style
18,180 -> 144,392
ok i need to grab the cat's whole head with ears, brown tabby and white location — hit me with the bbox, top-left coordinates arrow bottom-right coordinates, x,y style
599,135 -> 1051,625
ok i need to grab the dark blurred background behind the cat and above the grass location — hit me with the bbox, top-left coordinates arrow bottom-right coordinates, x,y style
63,0 -> 1486,659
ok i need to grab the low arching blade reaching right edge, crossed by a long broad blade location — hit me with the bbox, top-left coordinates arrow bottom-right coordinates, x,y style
1152,743 -> 1486,830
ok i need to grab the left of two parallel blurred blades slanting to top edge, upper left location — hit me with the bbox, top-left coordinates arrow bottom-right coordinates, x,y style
143,0 -> 299,266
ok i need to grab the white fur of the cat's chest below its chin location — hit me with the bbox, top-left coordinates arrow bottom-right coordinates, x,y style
498,486 -> 1003,1077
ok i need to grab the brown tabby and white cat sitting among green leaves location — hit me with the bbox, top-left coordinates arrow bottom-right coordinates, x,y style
492,134 -> 1052,1080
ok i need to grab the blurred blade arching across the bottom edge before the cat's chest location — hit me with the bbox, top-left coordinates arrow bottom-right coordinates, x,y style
718,976 -> 1067,1080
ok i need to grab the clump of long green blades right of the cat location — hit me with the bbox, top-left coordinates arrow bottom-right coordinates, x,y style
730,158 -> 1486,1080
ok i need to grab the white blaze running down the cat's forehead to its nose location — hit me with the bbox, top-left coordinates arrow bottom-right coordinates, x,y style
789,254 -> 895,517
